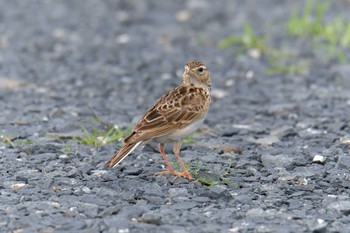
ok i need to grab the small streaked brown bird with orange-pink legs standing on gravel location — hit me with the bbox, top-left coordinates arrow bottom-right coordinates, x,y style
105,60 -> 211,180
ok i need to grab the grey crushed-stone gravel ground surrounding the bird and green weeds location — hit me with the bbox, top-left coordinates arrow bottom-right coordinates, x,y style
0,0 -> 350,233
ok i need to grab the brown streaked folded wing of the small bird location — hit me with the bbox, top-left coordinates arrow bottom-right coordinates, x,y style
125,85 -> 210,142
